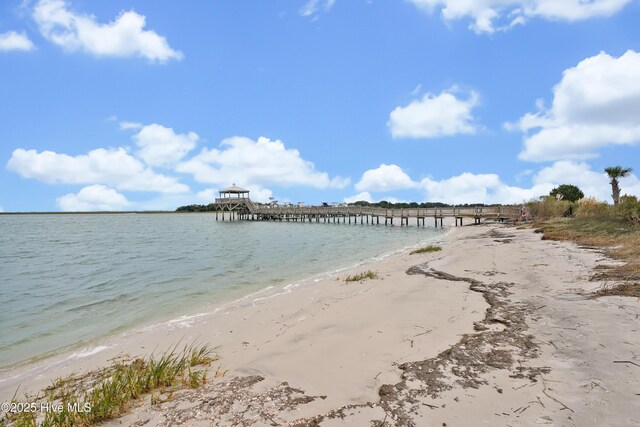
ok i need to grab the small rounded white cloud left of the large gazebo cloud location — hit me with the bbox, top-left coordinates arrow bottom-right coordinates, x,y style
131,123 -> 199,166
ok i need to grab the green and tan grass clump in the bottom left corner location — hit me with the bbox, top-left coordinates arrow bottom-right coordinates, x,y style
0,345 -> 224,427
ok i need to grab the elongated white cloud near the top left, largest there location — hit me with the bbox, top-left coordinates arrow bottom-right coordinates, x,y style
33,0 -> 184,63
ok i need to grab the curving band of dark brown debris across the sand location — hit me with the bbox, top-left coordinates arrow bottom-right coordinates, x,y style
362,264 -> 549,426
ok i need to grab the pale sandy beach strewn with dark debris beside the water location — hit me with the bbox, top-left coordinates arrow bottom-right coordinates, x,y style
0,224 -> 640,426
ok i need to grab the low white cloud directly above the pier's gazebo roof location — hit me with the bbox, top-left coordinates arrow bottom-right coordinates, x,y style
176,136 -> 349,188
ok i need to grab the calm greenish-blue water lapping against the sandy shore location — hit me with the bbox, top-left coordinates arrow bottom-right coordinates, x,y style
0,214 -> 444,371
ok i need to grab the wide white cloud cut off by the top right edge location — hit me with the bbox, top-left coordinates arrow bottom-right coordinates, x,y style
410,0 -> 632,34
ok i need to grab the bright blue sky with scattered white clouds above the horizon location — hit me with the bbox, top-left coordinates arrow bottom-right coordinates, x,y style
0,0 -> 640,211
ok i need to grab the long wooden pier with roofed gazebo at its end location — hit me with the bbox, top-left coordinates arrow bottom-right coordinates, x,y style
214,185 -> 520,227
